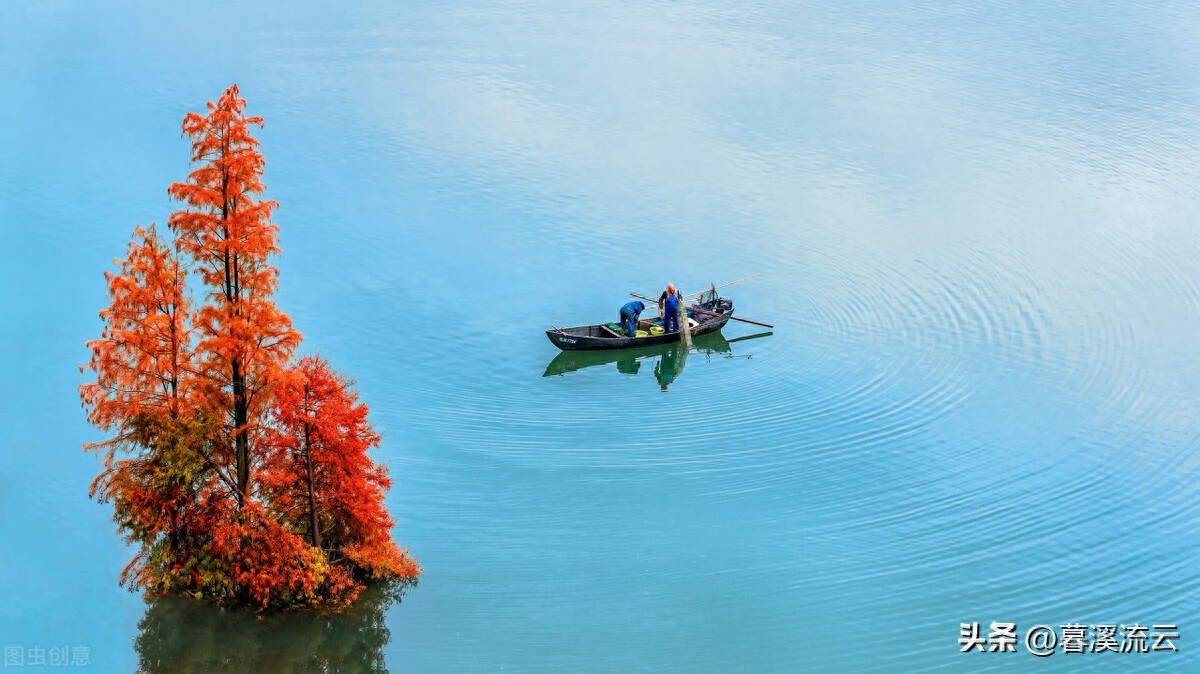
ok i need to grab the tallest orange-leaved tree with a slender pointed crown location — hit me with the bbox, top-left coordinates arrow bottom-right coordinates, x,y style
168,85 -> 300,506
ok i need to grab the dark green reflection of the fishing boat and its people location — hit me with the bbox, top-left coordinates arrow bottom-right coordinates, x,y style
542,332 -> 773,391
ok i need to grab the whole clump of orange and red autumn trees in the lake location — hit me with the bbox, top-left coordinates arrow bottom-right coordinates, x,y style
80,85 -> 420,608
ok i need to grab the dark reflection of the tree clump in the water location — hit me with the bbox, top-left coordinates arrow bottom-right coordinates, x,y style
133,583 -> 409,674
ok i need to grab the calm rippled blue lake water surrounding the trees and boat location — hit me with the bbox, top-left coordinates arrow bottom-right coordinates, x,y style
0,0 -> 1200,672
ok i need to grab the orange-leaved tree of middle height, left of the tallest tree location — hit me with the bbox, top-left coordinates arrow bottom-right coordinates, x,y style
79,225 -> 211,585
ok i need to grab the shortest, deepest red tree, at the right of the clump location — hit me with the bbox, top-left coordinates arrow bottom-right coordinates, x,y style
262,356 -> 419,594
